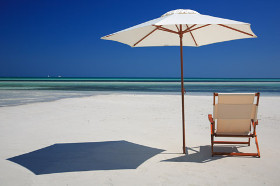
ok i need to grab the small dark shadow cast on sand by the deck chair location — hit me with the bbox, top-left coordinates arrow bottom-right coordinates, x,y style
162,145 -> 249,163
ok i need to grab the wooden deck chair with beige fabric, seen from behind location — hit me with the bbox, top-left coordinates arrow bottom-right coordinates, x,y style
208,93 -> 260,157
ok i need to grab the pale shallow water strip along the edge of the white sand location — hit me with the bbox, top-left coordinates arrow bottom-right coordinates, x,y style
0,90 -> 280,107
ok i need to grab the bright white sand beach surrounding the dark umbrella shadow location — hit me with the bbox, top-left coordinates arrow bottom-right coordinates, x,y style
0,94 -> 280,185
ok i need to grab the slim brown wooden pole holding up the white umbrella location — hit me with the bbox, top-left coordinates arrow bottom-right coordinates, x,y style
179,25 -> 186,154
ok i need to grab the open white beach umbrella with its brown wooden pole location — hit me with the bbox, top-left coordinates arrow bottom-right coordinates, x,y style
101,9 -> 256,153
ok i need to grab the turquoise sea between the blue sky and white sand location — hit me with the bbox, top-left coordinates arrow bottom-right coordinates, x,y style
0,78 -> 280,106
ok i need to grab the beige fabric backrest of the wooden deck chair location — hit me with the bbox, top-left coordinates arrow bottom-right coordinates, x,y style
213,93 -> 259,135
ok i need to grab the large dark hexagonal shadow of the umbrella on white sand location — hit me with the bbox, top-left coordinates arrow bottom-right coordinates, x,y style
8,141 -> 164,175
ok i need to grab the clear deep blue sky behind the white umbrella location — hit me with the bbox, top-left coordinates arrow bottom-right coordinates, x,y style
0,0 -> 280,78
